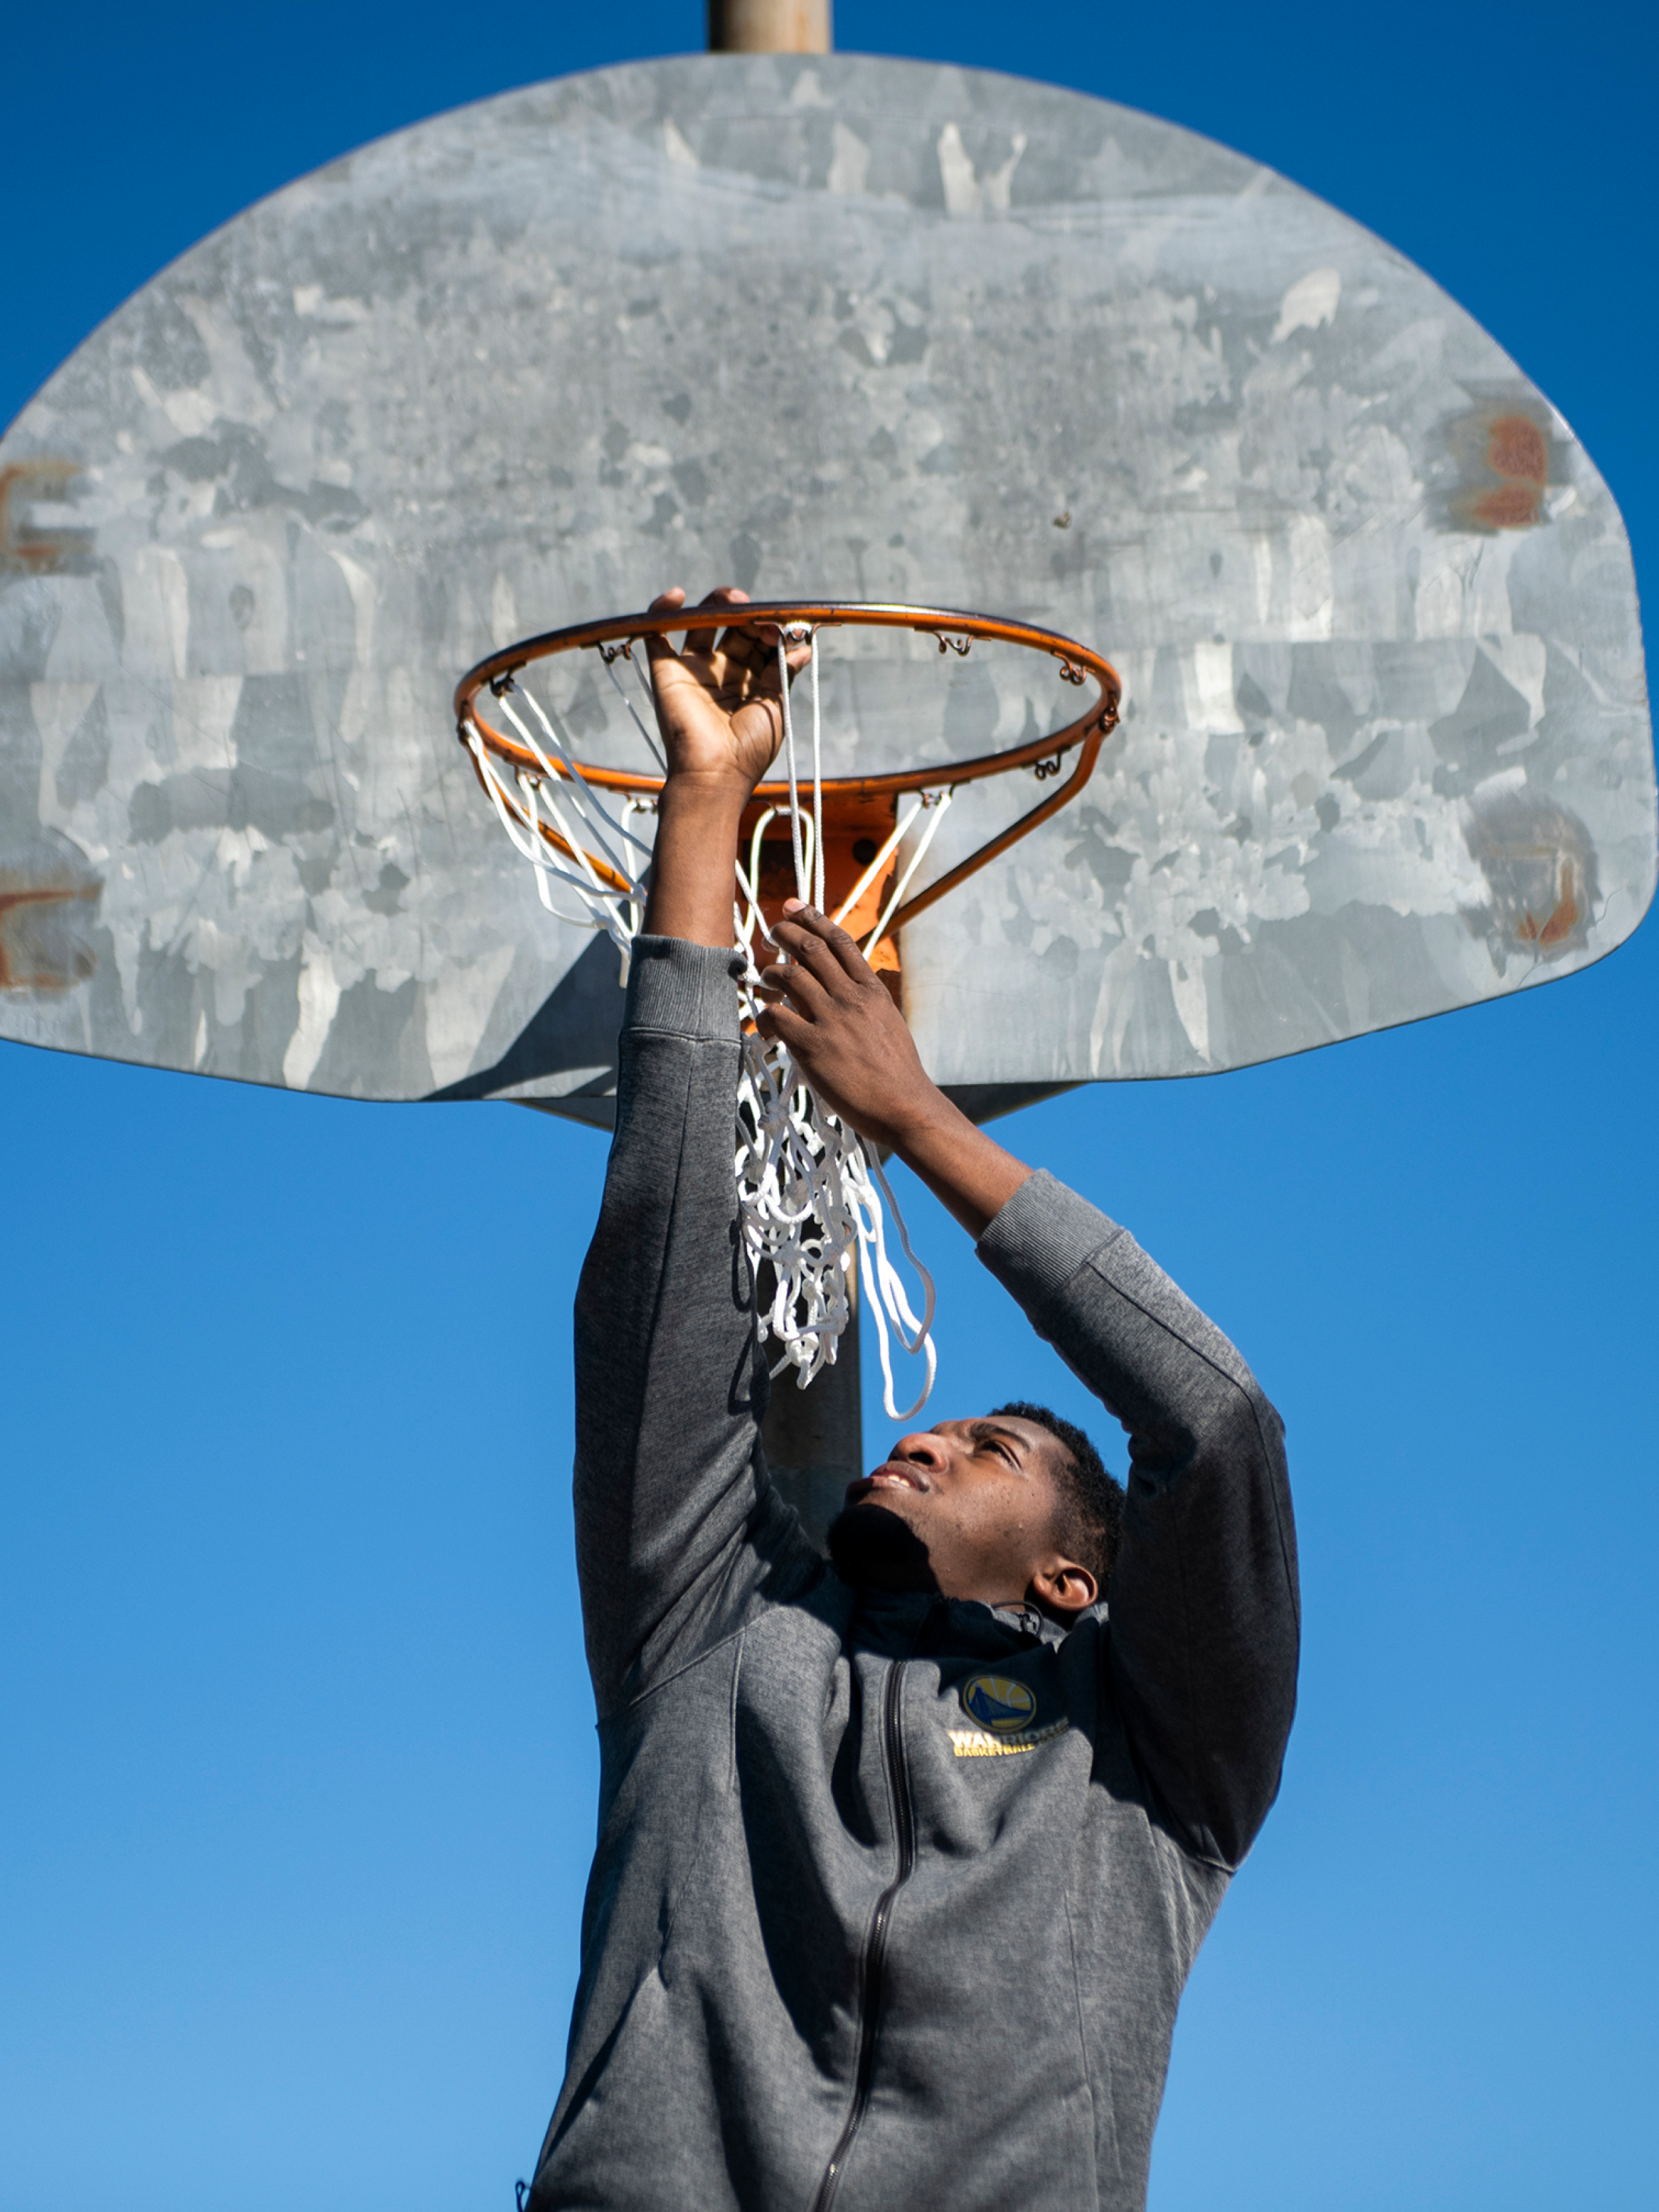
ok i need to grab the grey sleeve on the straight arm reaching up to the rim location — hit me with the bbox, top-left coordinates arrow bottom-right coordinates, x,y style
575,938 -> 816,1717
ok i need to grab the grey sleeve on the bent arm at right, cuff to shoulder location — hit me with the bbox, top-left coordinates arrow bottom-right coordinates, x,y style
978,1172 -> 1301,1867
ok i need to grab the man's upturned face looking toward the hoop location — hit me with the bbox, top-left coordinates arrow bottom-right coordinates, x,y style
830,1414 -> 1093,1606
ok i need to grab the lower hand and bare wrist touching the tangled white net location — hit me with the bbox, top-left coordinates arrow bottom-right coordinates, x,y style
759,900 -> 1031,1236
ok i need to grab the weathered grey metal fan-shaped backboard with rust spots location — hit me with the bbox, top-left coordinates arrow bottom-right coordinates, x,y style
0,58 -> 1654,1119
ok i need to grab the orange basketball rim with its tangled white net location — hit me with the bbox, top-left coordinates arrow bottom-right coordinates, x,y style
456,600 -> 1121,1420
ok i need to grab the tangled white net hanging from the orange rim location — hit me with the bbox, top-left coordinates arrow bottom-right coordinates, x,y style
465,626 -> 951,1420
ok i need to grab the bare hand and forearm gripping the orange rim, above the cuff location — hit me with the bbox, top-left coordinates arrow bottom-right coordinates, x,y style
643,584 -> 810,946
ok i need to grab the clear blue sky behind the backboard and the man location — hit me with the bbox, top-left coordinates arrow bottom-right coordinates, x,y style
0,0 -> 1659,2212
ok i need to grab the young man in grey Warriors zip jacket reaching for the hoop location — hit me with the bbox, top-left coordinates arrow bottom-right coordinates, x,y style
531,593 -> 1296,2212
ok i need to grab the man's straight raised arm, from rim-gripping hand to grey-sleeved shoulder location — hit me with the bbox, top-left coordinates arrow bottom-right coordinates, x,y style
575,593 -> 814,1714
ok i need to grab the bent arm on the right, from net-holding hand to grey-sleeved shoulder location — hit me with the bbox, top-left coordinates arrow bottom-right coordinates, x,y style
763,909 -> 1299,1867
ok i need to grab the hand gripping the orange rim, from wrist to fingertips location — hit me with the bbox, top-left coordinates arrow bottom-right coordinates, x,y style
646,584 -> 812,801
